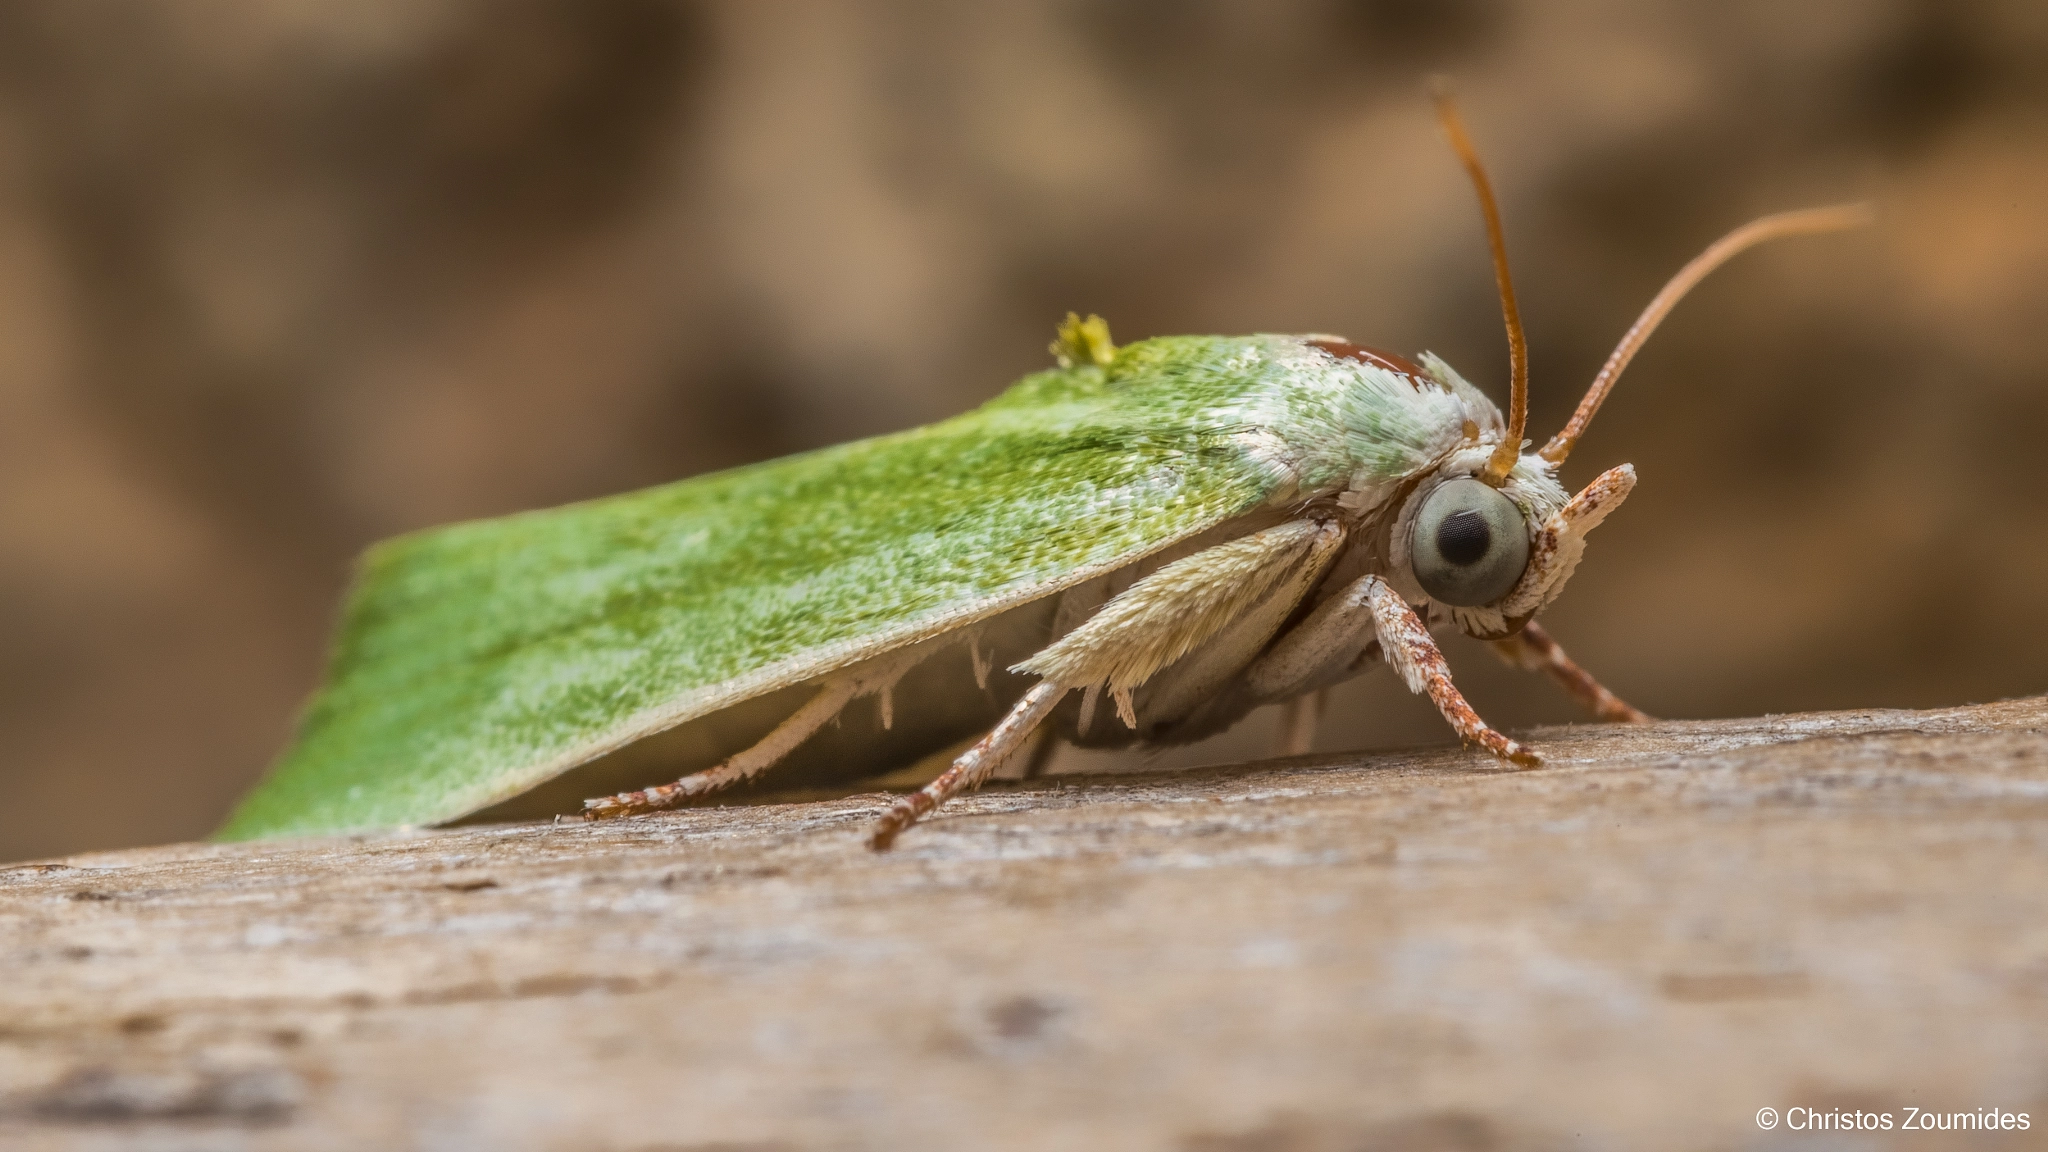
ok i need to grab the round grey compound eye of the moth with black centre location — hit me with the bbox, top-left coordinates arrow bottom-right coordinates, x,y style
1409,478 -> 1530,609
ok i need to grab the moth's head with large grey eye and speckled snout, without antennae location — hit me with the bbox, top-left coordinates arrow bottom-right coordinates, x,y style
1389,449 -> 1636,640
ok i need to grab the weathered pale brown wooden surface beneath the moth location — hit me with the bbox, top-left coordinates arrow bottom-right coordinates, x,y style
0,697 -> 2048,1152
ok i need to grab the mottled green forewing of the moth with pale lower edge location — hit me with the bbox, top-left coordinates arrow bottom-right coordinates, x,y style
221,338 -> 1310,838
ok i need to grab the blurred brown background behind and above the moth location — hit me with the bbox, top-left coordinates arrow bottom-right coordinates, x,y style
0,0 -> 2048,859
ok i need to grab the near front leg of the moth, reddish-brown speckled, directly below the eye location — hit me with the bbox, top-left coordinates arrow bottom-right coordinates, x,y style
1245,576 -> 1542,769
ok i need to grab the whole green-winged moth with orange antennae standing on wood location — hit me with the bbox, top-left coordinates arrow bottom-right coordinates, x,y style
221,96 -> 1868,849
